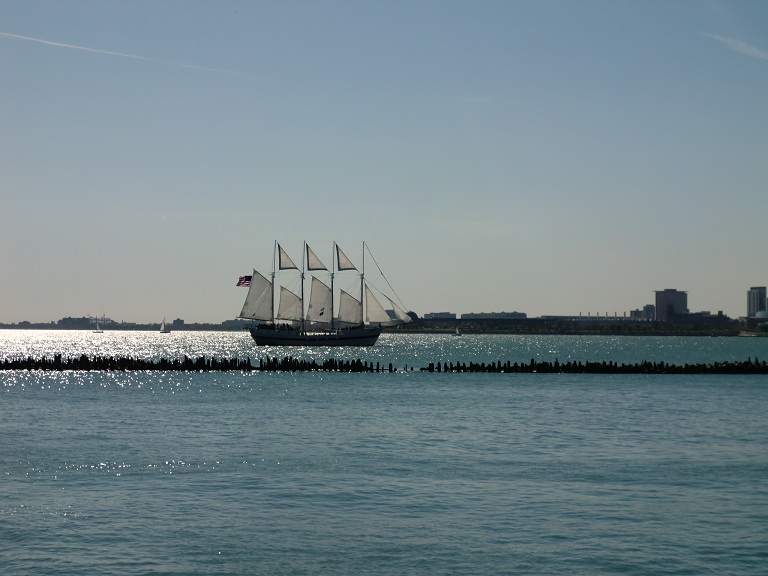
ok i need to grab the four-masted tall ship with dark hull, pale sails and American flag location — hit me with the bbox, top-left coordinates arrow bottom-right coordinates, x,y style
238,242 -> 411,346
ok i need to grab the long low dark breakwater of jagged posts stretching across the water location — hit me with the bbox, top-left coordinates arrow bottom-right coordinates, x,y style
0,354 -> 768,374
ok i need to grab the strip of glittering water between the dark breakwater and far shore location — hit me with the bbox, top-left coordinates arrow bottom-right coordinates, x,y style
0,330 -> 768,369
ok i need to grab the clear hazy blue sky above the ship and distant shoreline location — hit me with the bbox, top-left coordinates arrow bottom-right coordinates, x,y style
0,0 -> 768,323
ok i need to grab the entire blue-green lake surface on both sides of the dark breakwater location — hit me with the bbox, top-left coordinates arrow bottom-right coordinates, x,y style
0,330 -> 768,575
